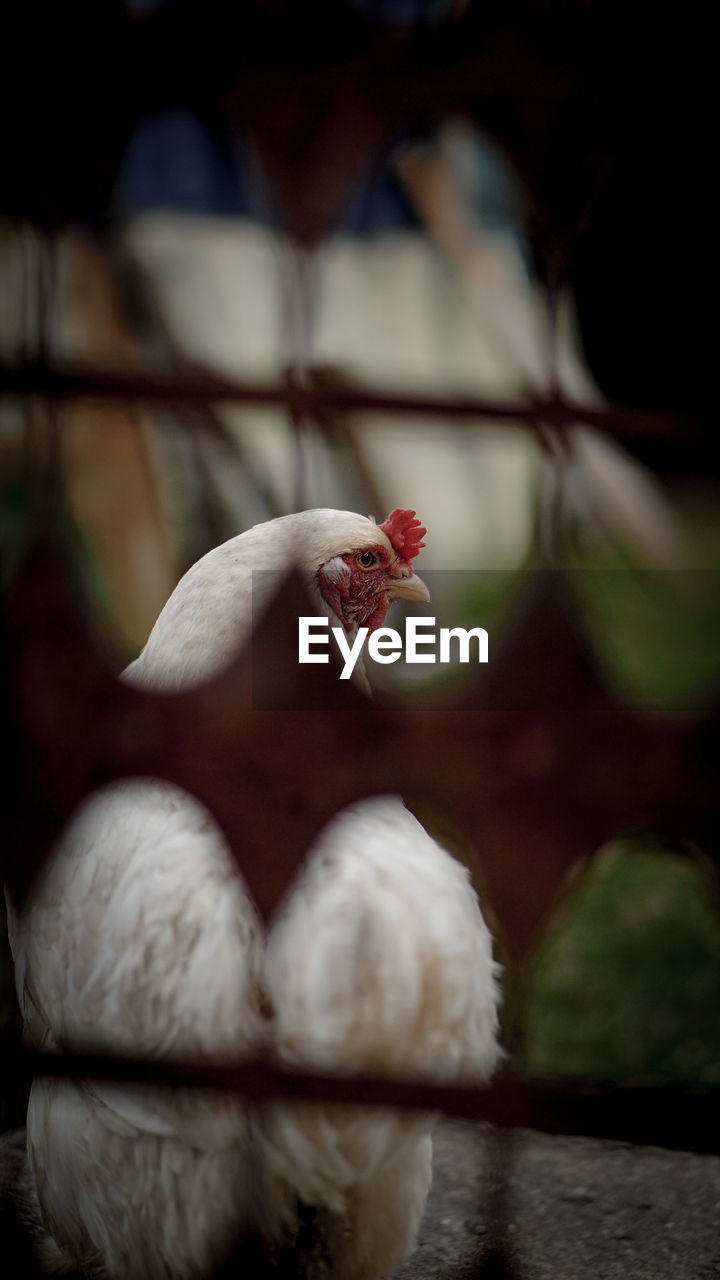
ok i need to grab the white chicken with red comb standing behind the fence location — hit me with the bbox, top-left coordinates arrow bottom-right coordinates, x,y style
5,509 -> 500,1280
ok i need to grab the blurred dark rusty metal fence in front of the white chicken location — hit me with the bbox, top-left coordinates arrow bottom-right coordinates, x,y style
0,5 -> 720,1276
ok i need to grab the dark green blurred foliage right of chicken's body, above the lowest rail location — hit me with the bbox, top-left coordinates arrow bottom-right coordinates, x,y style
523,841 -> 720,1085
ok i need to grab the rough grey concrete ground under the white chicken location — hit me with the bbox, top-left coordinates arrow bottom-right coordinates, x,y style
0,1123 -> 720,1280
